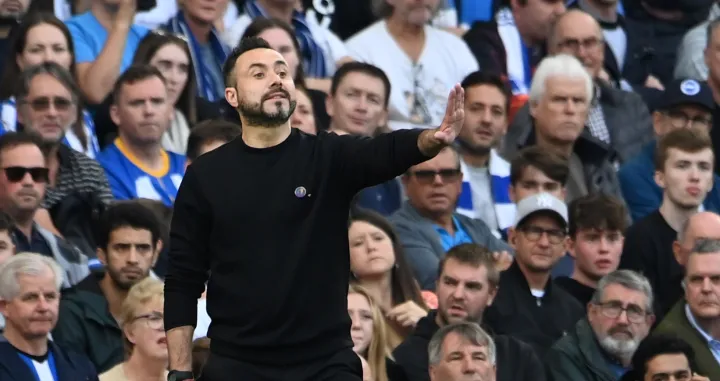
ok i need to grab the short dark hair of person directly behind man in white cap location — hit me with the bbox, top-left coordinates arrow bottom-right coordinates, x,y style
510,146 -> 570,186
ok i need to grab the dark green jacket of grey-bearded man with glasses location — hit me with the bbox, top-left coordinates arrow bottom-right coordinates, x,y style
545,318 -> 618,381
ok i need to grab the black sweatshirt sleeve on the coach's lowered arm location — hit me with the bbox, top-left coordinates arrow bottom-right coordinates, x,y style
164,166 -> 212,330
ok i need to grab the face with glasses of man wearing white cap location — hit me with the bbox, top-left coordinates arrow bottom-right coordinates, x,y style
509,212 -> 565,273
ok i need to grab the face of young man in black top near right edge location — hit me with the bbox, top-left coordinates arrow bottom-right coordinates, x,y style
655,148 -> 714,209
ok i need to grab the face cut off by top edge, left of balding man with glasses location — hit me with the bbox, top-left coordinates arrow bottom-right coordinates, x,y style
510,0 -> 565,44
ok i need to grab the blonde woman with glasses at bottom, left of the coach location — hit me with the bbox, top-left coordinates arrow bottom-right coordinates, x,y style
100,277 -> 168,381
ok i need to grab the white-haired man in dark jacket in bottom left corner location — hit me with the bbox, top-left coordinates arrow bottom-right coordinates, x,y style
0,253 -> 98,381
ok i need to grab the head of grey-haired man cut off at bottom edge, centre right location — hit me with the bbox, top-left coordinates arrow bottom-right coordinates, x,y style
428,322 -> 496,381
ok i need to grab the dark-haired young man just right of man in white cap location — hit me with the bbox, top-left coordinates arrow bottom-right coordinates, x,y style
555,194 -> 627,305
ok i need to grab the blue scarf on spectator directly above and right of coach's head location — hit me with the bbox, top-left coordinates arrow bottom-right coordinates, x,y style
245,1 -> 329,78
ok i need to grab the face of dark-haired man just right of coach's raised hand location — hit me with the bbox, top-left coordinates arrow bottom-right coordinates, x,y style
458,85 -> 508,153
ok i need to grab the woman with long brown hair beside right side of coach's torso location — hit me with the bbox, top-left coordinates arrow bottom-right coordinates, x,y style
348,208 -> 436,350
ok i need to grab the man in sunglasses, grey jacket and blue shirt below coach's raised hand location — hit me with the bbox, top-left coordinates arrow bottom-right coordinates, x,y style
391,147 -> 512,291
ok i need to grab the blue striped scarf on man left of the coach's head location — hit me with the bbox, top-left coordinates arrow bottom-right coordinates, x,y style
167,11 -> 229,102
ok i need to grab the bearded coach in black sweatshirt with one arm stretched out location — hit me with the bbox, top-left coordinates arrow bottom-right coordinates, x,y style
165,38 -> 464,381
